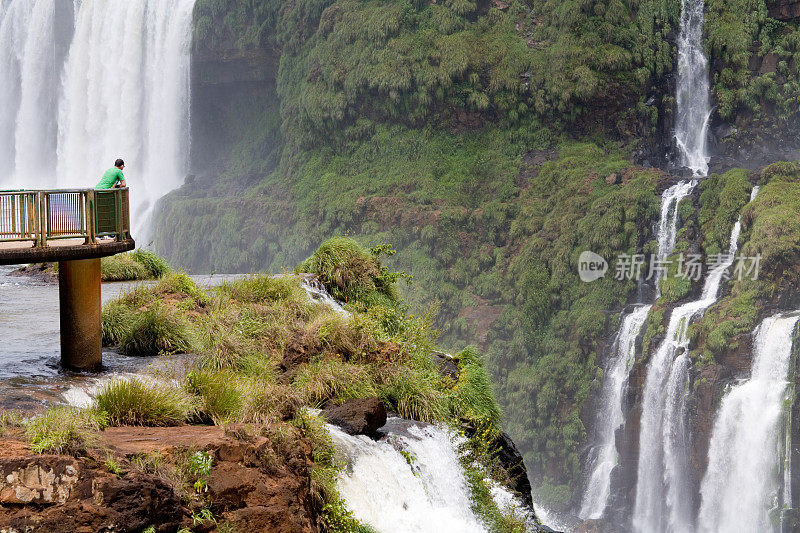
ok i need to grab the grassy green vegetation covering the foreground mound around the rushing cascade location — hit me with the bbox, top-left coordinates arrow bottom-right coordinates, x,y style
90,238 -> 528,533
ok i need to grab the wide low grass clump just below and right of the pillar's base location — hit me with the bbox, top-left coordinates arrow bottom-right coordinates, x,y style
95,379 -> 195,426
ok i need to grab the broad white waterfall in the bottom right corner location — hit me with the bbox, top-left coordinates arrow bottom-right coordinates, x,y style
698,313 -> 800,532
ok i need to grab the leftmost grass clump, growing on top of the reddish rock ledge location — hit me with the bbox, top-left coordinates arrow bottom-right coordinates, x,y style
25,407 -> 108,455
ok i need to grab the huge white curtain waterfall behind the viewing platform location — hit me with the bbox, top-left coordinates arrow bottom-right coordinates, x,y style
0,0 -> 194,232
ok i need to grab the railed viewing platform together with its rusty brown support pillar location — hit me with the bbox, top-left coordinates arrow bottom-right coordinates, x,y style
0,188 -> 136,370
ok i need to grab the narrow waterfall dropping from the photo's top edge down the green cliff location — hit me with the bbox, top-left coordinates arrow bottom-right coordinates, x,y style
675,0 -> 711,176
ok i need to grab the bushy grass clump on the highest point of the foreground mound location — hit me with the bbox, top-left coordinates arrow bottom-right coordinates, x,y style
295,237 -> 404,305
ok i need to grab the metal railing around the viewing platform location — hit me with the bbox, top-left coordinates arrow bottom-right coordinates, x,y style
0,187 -> 130,246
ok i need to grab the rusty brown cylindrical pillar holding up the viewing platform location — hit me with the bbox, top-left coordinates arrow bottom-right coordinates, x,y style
58,259 -> 103,370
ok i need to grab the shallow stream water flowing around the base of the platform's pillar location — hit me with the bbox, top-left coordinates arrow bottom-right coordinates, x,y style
0,266 -> 237,412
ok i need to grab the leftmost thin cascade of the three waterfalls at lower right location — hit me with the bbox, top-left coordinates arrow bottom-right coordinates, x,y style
579,181 -> 696,519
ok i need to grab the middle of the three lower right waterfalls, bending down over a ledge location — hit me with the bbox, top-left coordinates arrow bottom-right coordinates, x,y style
633,188 -> 758,533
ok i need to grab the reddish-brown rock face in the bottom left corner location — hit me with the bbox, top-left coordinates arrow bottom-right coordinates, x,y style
0,426 -> 319,533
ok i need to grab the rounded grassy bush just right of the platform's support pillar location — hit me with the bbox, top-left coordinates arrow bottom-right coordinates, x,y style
117,303 -> 194,357
